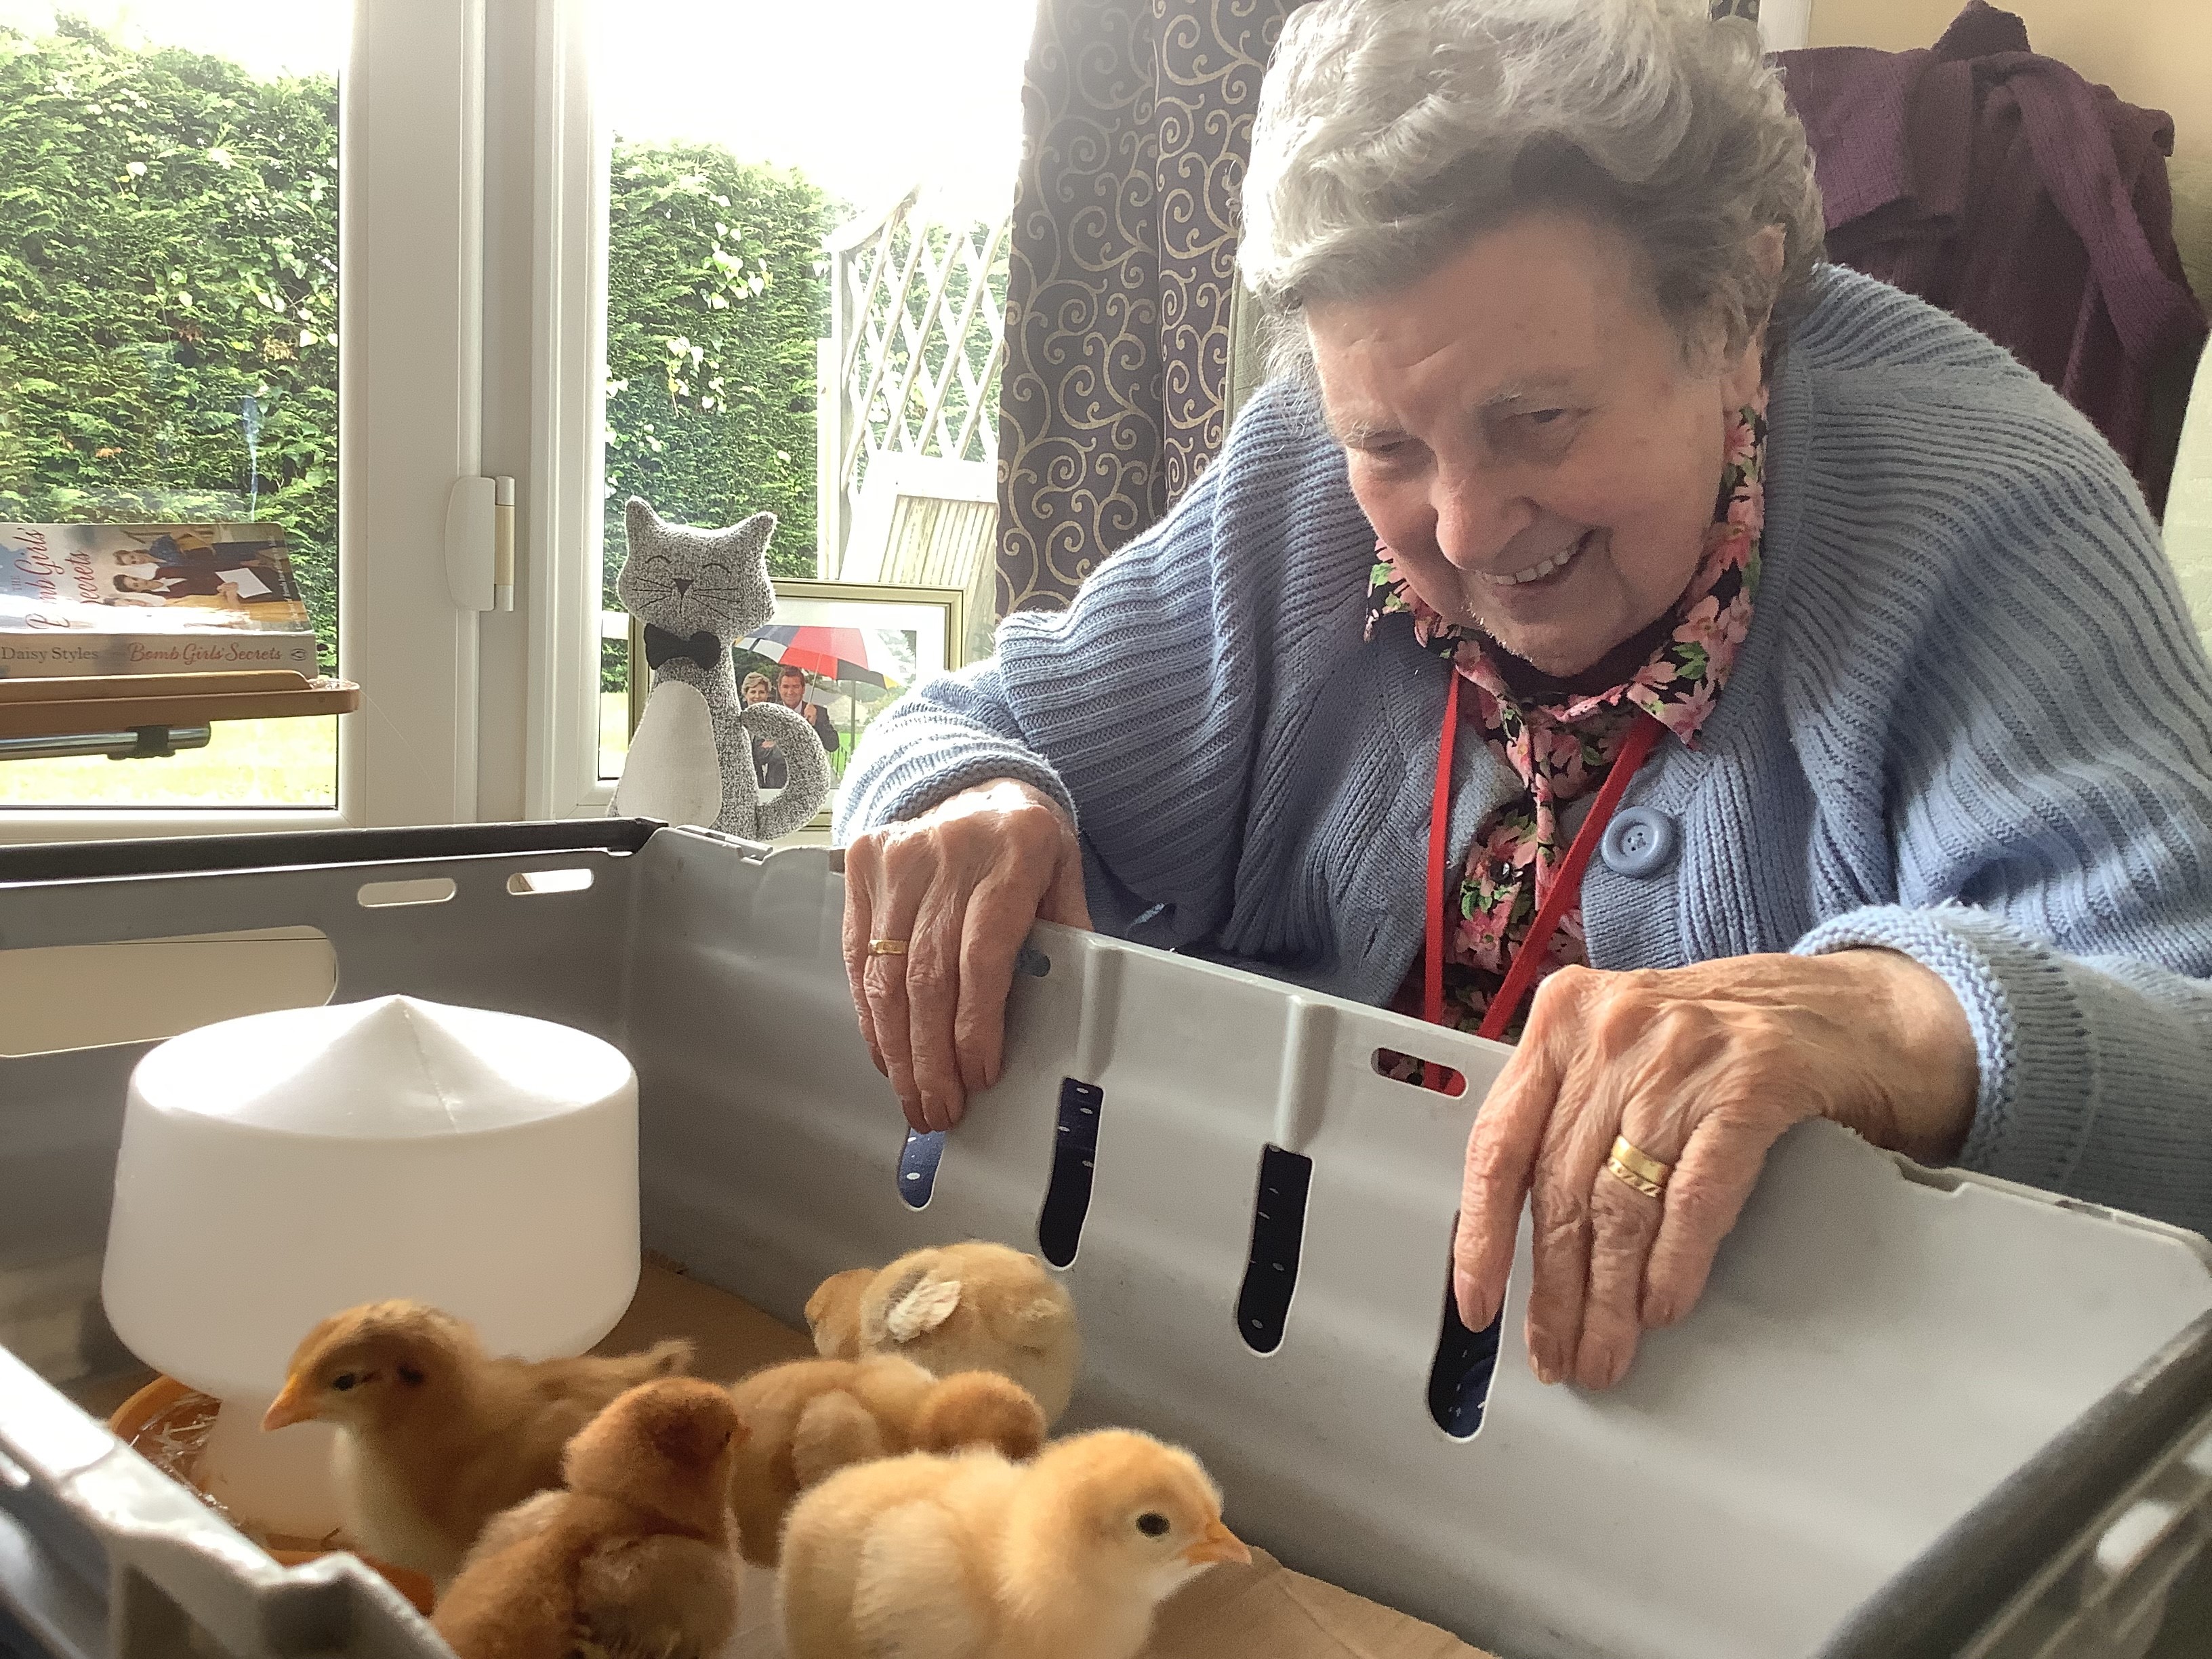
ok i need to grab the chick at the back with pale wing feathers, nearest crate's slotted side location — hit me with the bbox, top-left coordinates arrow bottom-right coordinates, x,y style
807,1239 -> 1082,1425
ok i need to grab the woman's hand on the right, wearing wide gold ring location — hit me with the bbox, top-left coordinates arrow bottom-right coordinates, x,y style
1453,949 -> 1980,1387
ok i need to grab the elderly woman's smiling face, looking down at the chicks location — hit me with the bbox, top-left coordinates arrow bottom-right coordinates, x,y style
1305,210 -> 1761,677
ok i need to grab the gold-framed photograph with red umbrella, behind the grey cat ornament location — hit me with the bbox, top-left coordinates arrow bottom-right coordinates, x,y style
630,575 -> 966,830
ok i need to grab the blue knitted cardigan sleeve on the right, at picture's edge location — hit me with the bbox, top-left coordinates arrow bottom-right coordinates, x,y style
1796,431 -> 2212,1232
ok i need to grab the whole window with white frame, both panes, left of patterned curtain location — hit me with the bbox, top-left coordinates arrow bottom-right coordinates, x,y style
0,0 -> 1033,838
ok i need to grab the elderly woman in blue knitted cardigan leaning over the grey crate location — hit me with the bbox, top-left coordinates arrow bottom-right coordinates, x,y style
840,0 -> 2212,1387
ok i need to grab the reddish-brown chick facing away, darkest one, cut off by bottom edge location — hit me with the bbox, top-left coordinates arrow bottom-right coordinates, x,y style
431,1378 -> 745,1659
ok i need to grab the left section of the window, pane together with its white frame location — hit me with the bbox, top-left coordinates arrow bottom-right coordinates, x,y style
0,0 -> 483,838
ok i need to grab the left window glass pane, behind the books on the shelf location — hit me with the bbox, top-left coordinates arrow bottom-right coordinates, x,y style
0,0 -> 350,807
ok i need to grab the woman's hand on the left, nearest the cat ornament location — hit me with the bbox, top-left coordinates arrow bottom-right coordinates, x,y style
845,779 -> 1090,1130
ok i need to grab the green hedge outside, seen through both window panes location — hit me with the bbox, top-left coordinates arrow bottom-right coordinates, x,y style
0,20 -> 834,688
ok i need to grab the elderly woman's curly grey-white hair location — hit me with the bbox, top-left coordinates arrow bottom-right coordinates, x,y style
1239,0 -> 1823,374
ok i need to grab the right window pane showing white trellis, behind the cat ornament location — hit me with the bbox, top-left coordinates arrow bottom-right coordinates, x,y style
593,0 -> 1036,777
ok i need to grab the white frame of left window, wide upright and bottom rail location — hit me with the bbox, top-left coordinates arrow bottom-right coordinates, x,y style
0,0 -> 493,843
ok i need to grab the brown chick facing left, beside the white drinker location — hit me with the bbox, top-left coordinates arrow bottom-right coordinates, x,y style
261,1300 -> 693,1589
